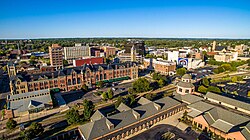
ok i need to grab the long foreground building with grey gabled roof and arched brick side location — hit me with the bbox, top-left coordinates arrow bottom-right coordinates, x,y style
78,97 -> 185,140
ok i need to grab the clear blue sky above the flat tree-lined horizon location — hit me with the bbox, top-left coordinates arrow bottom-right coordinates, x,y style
0,0 -> 250,39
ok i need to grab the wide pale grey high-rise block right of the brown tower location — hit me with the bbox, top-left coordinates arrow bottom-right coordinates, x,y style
63,43 -> 90,61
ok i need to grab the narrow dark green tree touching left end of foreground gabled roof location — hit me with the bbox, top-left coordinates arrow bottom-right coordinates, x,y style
83,99 -> 95,120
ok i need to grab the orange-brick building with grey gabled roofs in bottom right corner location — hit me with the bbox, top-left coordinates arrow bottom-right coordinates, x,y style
187,101 -> 250,140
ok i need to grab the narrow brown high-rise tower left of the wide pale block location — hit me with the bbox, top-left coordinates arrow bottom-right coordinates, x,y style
49,44 -> 63,68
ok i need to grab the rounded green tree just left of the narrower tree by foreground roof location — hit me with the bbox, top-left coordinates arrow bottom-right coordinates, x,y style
66,108 -> 81,124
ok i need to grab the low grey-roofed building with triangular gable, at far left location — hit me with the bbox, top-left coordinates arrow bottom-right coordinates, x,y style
7,89 -> 53,117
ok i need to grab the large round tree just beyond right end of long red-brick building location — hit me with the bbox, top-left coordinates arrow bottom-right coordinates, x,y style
132,78 -> 151,93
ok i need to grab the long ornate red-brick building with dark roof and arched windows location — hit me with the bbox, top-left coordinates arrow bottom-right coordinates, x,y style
10,62 -> 138,94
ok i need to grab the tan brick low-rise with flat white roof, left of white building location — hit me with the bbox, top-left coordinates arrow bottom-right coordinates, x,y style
143,58 -> 176,75
